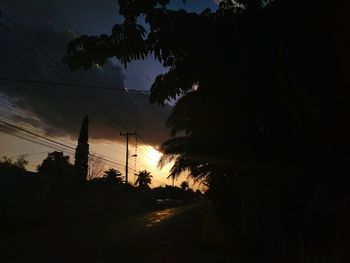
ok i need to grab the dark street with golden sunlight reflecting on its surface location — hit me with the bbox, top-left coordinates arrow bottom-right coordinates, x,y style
0,201 -> 232,263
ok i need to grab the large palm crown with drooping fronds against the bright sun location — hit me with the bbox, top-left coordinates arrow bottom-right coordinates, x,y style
158,92 -> 217,186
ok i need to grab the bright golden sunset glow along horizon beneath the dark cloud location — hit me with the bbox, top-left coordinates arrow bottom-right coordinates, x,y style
0,132 -> 197,190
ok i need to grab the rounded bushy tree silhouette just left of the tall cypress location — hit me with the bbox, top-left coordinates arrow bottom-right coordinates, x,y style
37,151 -> 74,184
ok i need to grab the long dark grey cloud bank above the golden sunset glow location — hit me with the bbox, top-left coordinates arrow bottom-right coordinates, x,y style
0,25 -> 171,145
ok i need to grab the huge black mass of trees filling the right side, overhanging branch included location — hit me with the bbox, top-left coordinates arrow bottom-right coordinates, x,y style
64,0 -> 350,262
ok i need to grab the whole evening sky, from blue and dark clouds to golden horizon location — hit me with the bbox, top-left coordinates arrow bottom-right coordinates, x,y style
0,0 -> 217,190
